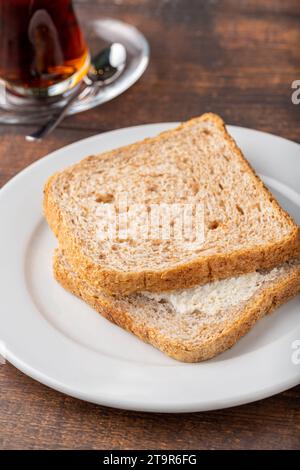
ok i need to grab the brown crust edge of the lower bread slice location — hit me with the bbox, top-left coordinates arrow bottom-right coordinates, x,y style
53,252 -> 300,362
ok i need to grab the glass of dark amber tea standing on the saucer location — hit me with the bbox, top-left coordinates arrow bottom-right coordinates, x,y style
0,0 -> 89,95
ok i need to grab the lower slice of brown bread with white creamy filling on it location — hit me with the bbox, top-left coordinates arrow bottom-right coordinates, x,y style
54,250 -> 300,362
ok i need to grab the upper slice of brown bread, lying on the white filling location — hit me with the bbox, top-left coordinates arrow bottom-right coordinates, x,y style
44,114 -> 300,294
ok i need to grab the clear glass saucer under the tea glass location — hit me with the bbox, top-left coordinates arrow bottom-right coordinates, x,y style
0,18 -> 149,124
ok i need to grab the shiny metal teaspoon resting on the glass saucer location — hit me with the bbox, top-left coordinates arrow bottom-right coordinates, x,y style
26,42 -> 126,142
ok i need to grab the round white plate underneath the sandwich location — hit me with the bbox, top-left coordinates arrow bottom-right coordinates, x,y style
0,123 -> 300,412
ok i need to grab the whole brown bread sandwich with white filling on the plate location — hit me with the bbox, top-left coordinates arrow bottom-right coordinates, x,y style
44,113 -> 300,362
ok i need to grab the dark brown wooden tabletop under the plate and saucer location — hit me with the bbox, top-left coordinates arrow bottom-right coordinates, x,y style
0,0 -> 300,449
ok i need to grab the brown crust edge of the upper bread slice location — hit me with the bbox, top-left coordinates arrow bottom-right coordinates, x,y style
44,113 -> 300,294
